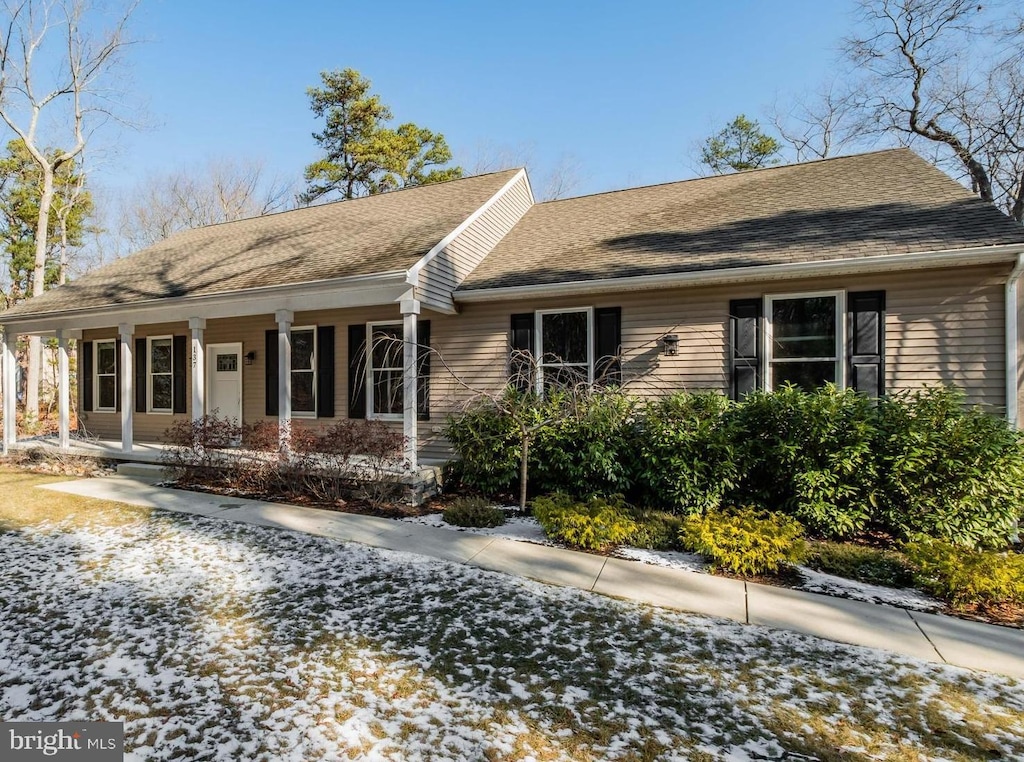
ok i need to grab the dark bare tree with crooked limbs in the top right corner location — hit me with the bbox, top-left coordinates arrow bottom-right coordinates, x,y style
846,0 -> 1024,222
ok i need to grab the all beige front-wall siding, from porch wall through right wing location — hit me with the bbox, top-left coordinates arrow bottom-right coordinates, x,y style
75,265 -> 1009,460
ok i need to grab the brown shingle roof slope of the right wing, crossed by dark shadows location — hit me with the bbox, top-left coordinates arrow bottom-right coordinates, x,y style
459,149 -> 1024,291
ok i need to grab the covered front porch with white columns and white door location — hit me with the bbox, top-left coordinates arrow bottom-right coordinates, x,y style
0,271 -> 429,472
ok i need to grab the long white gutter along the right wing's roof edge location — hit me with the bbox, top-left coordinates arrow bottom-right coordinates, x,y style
453,244 -> 1021,302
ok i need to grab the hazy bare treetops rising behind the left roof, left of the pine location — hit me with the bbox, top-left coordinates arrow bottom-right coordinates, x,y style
118,159 -> 293,251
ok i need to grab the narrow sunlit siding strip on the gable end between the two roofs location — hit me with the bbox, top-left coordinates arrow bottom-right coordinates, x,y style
417,173 -> 534,310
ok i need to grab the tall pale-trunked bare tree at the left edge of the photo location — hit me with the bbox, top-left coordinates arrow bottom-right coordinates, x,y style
0,0 -> 137,415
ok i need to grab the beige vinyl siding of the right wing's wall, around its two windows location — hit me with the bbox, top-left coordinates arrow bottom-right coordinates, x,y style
420,265 -> 1007,460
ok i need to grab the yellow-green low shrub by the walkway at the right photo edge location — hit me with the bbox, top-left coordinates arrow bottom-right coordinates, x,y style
904,539 -> 1024,607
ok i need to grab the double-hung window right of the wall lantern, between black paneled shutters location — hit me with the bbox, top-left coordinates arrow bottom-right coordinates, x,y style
765,291 -> 846,390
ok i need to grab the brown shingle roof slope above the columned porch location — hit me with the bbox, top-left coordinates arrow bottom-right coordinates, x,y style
0,169 -> 518,321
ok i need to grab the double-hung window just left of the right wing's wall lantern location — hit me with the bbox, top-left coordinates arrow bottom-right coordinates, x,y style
535,307 -> 594,394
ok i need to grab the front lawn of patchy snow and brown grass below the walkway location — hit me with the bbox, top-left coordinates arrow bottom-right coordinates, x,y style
0,473 -> 1024,761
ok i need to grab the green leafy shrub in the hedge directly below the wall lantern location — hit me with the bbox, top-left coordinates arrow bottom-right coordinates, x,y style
629,392 -> 736,513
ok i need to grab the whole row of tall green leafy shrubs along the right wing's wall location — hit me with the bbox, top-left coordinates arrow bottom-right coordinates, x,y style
446,386 -> 1024,546
